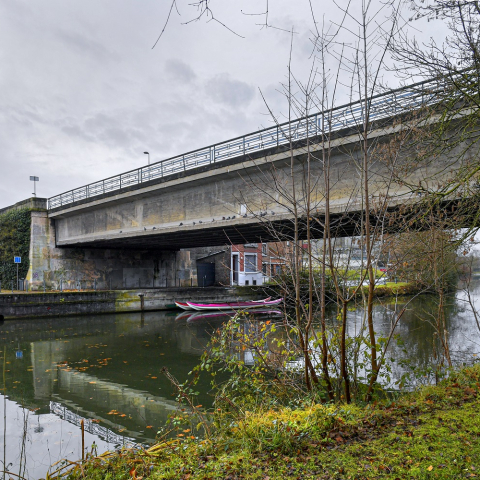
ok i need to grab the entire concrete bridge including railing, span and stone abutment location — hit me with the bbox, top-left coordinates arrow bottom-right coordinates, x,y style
2,79 -> 477,287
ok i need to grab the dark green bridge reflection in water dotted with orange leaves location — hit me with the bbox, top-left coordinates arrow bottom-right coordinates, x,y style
1,312 -> 218,441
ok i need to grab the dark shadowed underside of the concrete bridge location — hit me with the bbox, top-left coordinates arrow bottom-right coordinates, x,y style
58,198 -> 480,251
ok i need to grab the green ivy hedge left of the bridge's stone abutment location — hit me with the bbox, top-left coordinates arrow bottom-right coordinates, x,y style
0,208 -> 32,288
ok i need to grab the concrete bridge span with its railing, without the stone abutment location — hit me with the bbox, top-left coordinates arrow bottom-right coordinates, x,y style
48,82 -> 442,250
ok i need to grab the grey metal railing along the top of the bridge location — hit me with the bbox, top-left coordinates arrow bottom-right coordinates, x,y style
48,76 -> 440,209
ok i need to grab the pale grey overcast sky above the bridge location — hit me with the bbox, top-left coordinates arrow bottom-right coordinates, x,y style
0,0 -> 440,208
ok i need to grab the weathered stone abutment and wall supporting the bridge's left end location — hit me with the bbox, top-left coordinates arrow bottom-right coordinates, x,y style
27,211 -> 196,290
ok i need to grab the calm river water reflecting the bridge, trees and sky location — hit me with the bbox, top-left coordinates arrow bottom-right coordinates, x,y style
0,284 -> 480,479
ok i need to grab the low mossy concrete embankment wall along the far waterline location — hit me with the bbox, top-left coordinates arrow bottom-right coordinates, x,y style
0,287 -> 256,319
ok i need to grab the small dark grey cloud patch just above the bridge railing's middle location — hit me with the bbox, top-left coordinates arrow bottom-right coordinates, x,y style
205,74 -> 255,107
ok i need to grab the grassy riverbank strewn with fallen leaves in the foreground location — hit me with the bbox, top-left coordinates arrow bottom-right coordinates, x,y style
48,364 -> 480,480
